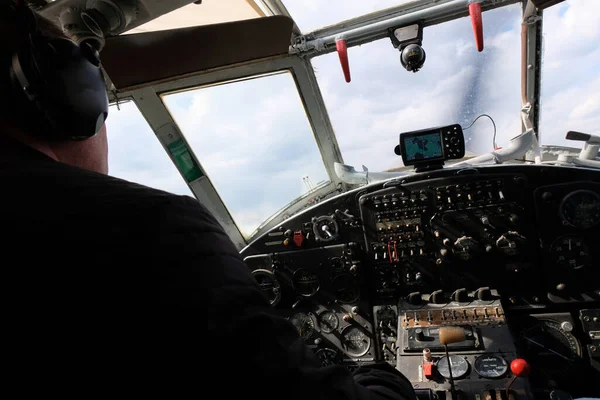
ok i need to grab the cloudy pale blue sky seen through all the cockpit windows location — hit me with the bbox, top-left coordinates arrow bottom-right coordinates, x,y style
108,0 -> 600,234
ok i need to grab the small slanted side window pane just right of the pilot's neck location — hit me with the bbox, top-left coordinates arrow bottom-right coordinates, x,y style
106,102 -> 194,197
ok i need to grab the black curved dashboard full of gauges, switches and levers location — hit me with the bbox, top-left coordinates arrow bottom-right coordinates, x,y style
241,165 -> 600,400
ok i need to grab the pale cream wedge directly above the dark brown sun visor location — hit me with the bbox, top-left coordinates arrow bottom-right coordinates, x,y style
126,0 -> 265,33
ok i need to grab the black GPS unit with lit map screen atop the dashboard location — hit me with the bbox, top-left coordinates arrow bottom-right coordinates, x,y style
394,124 -> 465,172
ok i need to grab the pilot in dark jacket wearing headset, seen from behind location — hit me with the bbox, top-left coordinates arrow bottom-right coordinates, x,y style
0,0 -> 415,400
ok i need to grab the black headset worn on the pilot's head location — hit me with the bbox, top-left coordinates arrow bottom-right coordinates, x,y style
0,0 -> 108,140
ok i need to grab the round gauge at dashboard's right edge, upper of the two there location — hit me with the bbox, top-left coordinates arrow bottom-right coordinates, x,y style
560,190 -> 600,229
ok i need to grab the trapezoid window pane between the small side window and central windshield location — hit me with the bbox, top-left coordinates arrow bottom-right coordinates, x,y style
163,72 -> 328,237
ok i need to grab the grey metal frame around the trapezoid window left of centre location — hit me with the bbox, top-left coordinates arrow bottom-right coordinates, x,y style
112,55 -> 347,249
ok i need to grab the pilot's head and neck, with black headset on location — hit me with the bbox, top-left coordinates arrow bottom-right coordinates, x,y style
0,0 -> 108,174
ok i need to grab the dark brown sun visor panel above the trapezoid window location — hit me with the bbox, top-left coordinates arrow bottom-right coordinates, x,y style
102,16 -> 293,90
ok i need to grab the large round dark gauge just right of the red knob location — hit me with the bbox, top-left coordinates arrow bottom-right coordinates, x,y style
520,319 -> 581,379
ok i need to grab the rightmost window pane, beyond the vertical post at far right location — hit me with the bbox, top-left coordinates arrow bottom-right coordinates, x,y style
540,0 -> 600,147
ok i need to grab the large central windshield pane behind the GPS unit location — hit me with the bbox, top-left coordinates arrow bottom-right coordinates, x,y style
312,4 -> 521,171
